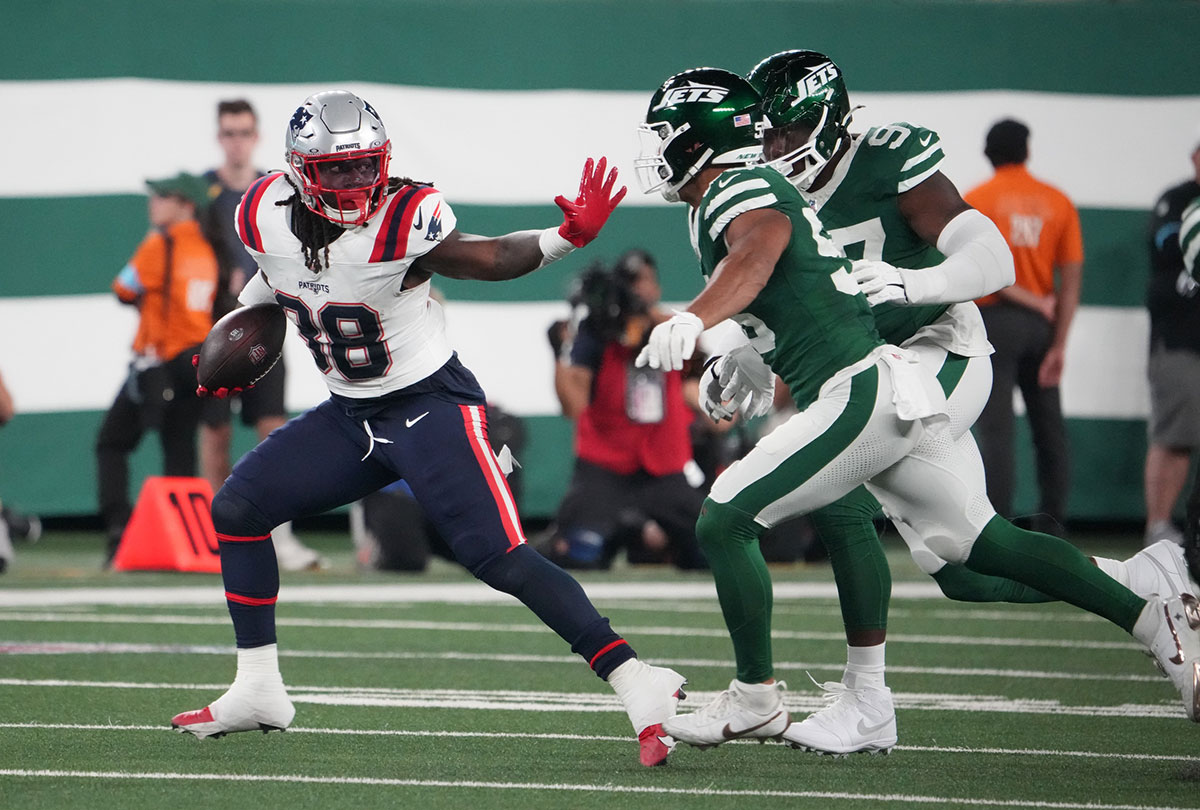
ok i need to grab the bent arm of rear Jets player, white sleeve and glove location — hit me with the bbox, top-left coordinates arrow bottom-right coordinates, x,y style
853,172 -> 1015,305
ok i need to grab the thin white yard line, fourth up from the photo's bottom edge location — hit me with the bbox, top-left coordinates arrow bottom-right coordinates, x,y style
0,640 -> 1162,683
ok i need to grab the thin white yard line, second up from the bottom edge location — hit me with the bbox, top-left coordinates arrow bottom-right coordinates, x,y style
0,722 -> 1196,762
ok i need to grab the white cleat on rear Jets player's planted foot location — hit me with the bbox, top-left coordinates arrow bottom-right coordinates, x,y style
784,682 -> 896,755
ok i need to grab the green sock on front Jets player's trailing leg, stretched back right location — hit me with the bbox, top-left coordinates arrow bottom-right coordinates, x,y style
966,515 -> 1146,632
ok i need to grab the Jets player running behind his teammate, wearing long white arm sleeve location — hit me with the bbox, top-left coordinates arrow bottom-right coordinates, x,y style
746,50 -> 1195,754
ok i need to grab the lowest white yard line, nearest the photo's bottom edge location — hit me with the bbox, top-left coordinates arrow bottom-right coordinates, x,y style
0,768 -> 1183,810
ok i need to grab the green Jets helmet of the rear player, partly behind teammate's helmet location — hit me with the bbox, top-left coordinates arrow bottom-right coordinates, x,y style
746,50 -> 853,190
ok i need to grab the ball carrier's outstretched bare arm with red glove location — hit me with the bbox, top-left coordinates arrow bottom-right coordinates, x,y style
414,157 -> 626,281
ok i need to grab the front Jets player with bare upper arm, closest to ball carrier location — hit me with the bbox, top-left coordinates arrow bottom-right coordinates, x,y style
635,68 -> 1200,746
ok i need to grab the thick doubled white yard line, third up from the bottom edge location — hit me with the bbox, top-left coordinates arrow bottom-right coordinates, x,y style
0,678 -> 1180,722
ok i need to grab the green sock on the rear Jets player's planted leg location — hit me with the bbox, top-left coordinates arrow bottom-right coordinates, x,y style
809,487 -> 892,634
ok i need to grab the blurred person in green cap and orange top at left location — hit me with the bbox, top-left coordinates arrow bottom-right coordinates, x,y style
96,174 -> 217,565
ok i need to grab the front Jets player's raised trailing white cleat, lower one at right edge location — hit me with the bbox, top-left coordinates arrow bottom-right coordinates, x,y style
1134,594 -> 1200,722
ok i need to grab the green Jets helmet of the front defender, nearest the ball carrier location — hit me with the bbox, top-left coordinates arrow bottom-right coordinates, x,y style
634,67 -> 762,203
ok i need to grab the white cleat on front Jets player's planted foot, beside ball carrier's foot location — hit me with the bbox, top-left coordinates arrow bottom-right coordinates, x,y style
662,679 -> 791,749
